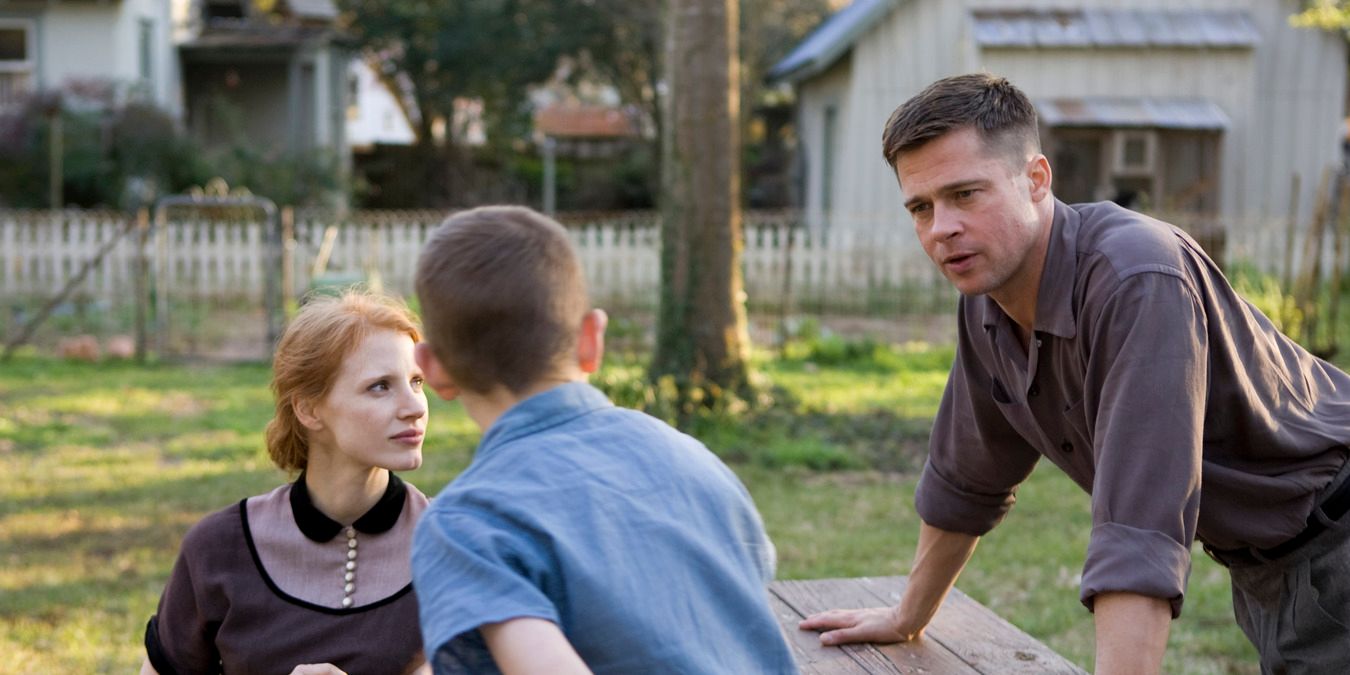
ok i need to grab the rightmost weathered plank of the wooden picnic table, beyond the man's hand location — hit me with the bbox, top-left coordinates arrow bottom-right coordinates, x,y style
864,576 -> 1085,675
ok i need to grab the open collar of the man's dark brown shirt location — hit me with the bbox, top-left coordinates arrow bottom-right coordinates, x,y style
980,200 -> 1079,338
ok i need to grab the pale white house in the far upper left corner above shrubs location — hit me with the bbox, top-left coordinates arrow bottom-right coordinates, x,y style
0,0 -> 180,115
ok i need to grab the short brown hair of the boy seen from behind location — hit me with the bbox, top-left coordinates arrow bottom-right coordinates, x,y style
416,207 -> 589,394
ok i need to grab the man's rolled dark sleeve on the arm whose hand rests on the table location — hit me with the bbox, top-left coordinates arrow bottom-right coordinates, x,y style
914,298 -> 1041,536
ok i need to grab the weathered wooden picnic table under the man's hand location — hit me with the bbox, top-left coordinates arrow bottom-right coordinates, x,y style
770,576 -> 1084,675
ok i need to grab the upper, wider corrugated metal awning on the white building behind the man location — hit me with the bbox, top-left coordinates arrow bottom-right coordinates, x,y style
972,9 -> 1261,47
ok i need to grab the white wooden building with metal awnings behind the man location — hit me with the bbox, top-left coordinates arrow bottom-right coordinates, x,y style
771,0 -> 1347,268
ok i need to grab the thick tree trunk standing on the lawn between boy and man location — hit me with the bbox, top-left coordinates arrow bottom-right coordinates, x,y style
651,0 -> 749,396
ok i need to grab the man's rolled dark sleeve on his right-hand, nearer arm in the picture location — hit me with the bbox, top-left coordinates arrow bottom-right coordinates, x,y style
1080,267 -> 1208,617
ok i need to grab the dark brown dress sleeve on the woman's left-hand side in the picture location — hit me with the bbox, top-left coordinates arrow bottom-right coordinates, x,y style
146,513 -> 228,675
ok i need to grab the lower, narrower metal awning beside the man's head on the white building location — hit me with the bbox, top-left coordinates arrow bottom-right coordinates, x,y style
1035,97 -> 1230,131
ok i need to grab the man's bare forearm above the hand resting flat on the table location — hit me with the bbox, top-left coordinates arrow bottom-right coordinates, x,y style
895,522 -> 980,640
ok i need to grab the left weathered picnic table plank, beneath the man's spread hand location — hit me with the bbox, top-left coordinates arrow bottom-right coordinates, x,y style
770,579 -> 979,674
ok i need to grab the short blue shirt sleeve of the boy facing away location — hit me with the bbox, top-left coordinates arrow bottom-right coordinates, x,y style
412,508 -> 559,664
